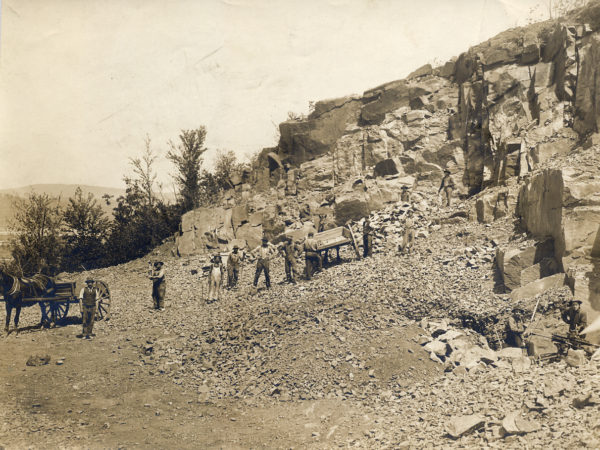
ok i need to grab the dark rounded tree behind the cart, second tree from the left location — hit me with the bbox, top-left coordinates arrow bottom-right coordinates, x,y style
63,187 -> 110,270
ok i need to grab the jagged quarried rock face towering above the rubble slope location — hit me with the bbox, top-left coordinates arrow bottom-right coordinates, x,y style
177,1 -> 600,316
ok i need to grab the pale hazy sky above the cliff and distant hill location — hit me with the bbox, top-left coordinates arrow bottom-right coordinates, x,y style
0,0 -> 539,188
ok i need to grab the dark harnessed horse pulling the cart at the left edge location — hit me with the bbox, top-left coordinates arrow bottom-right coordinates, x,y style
0,269 -> 55,334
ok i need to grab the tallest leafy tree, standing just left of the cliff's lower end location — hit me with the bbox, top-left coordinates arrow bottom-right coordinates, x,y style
167,126 -> 207,213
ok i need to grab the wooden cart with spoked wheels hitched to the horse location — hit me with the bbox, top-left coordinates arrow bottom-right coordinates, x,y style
3,281 -> 110,324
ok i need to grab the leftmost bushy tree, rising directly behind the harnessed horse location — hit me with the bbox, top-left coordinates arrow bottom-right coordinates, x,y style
11,192 -> 63,275
